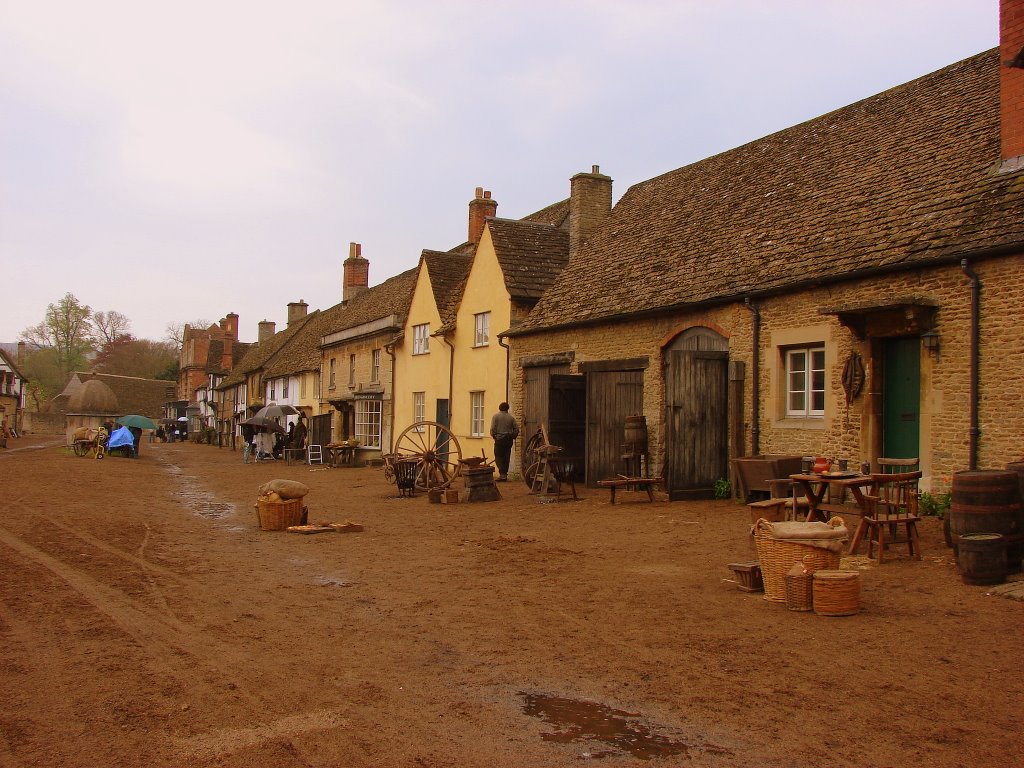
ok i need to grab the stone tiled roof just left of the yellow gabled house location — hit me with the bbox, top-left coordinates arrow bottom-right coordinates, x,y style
266,269 -> 416,377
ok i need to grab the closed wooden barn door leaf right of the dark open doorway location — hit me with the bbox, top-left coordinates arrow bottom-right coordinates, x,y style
587,371 -> 643,486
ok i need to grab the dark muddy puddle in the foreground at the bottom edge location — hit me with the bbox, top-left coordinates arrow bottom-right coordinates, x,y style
519,692 -> 689,760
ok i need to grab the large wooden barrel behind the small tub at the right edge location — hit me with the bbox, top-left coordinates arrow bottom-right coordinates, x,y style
948,470 -> 1024,573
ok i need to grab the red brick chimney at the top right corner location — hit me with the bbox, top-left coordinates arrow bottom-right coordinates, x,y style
999,0 -> 1024,171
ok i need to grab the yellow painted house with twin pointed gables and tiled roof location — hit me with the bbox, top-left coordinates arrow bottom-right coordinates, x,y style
392,188 -> 568,468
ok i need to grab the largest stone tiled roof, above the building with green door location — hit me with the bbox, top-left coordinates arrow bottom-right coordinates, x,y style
517,50 -> 1024,333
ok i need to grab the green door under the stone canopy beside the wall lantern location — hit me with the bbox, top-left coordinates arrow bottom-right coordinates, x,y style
882,338 -> 921,459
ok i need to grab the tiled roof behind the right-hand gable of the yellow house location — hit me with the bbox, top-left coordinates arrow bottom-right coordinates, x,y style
487,218 -> 569,302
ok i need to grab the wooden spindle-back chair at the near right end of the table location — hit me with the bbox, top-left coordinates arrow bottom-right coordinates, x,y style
851,468 -> 921,565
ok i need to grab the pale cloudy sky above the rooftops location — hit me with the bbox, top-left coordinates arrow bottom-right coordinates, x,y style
0,0 -> 998,342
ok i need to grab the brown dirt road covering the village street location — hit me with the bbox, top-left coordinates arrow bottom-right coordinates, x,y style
0,436 -> 1024,768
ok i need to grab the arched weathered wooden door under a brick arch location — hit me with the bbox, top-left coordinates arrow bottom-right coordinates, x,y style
665,328 -> 729,499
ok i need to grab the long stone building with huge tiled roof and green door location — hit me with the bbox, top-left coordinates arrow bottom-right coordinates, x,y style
510,0 -> 1024,498
